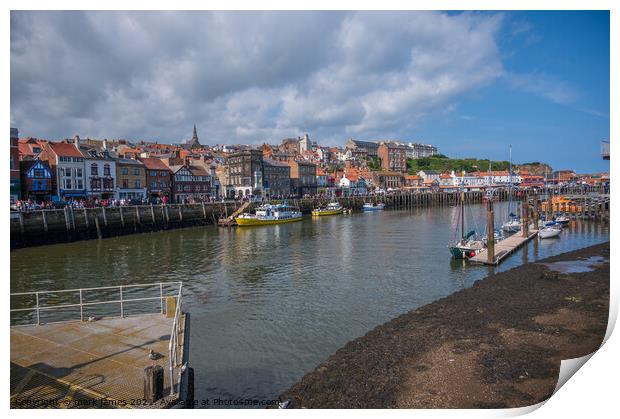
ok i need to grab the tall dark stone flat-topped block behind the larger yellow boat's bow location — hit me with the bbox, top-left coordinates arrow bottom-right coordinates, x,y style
226,150 -> 263,197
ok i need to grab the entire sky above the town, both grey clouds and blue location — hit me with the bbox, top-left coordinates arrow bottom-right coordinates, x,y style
10,11 -> 610,172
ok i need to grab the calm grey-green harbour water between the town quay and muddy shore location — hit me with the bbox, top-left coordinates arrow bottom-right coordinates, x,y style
11,203 -> 609,406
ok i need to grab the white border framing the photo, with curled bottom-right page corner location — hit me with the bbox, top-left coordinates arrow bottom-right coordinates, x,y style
0,0 -> 620,418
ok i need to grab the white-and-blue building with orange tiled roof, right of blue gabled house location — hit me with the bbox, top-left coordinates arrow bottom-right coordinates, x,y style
39,142 -> 86,200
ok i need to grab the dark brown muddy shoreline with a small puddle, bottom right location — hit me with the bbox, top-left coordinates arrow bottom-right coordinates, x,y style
280,242 -> 610,408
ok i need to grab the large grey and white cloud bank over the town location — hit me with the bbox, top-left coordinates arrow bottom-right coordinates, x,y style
11,12 -> 503,143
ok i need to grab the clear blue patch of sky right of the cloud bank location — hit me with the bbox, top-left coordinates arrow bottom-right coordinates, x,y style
419,12 -> 610,172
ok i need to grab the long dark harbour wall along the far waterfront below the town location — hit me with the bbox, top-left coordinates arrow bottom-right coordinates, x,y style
10,190 -> 609,249
